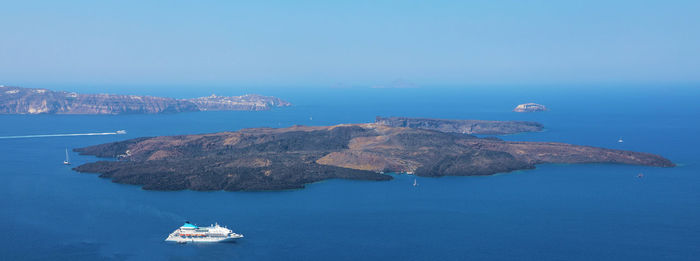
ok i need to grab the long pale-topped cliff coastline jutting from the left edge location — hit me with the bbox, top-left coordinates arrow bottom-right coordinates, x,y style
0,86 -> 291,114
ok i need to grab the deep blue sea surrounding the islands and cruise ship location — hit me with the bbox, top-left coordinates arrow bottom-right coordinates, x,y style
0,86 -> 700,261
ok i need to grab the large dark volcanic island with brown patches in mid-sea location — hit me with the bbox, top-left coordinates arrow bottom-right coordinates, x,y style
75,123 -> 674,191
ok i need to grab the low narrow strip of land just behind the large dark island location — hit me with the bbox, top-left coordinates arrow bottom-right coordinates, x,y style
375,116 -> 544,135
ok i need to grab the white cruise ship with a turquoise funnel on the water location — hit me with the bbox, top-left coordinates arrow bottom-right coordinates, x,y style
165,221 -> 243,243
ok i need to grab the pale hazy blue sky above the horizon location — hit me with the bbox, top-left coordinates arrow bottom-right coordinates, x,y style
0,0 -> 700,87
